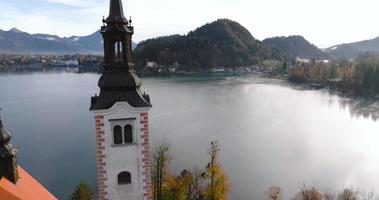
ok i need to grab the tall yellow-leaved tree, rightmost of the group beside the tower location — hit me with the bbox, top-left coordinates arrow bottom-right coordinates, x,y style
203,142 -> 229,200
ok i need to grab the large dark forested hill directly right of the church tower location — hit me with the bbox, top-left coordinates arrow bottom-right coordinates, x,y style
134,19 -> 284,69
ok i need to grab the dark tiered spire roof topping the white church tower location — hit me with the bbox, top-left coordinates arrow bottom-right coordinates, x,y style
90,0 -> 152,110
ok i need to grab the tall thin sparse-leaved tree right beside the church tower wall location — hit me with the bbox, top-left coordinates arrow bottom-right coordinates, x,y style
151,142 -> 171,200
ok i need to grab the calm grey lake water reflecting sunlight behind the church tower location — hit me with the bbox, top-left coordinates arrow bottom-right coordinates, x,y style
0,73 -> 379,200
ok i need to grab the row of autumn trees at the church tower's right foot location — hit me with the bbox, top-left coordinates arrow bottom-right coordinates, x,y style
151,142 -> 229,200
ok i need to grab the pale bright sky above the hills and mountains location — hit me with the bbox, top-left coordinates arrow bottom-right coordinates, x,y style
0,0 -> 379,48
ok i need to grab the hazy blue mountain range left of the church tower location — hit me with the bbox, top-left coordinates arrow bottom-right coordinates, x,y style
0,28 -> 138,54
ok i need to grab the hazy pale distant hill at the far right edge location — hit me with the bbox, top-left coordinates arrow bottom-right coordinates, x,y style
325,37 -> 379,59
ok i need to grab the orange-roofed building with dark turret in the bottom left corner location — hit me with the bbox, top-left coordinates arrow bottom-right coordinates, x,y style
0,115 -> 57,200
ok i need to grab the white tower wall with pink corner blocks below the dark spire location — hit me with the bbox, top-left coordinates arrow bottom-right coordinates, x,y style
93,102 -> 151,200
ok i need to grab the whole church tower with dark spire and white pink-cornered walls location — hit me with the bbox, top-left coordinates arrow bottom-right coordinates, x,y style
90,0 -> 151,200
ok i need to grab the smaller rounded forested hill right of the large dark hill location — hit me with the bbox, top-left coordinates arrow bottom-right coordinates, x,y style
263,35 -> 328,59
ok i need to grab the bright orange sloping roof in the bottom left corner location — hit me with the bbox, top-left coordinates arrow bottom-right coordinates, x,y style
0,166 -> 57,200
